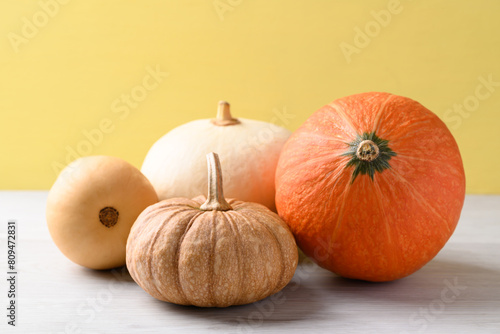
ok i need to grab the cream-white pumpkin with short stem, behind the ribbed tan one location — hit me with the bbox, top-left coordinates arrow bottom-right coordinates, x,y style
141,101 -> 290,210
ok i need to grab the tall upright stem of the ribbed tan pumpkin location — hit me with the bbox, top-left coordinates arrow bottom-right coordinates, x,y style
200,152 -> 233,211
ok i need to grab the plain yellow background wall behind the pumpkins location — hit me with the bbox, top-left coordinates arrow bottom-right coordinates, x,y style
0,0 -> 500,193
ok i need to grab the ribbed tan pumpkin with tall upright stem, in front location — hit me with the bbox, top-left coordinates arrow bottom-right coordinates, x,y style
127,153 -> 298,307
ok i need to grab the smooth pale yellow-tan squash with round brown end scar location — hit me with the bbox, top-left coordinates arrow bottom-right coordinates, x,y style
46,156 -> 158,269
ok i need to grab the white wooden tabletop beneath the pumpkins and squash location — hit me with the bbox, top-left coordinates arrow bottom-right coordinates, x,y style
0,191 -> 500,334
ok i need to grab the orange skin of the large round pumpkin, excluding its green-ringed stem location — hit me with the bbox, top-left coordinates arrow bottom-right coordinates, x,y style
276,93 -> 465,281
